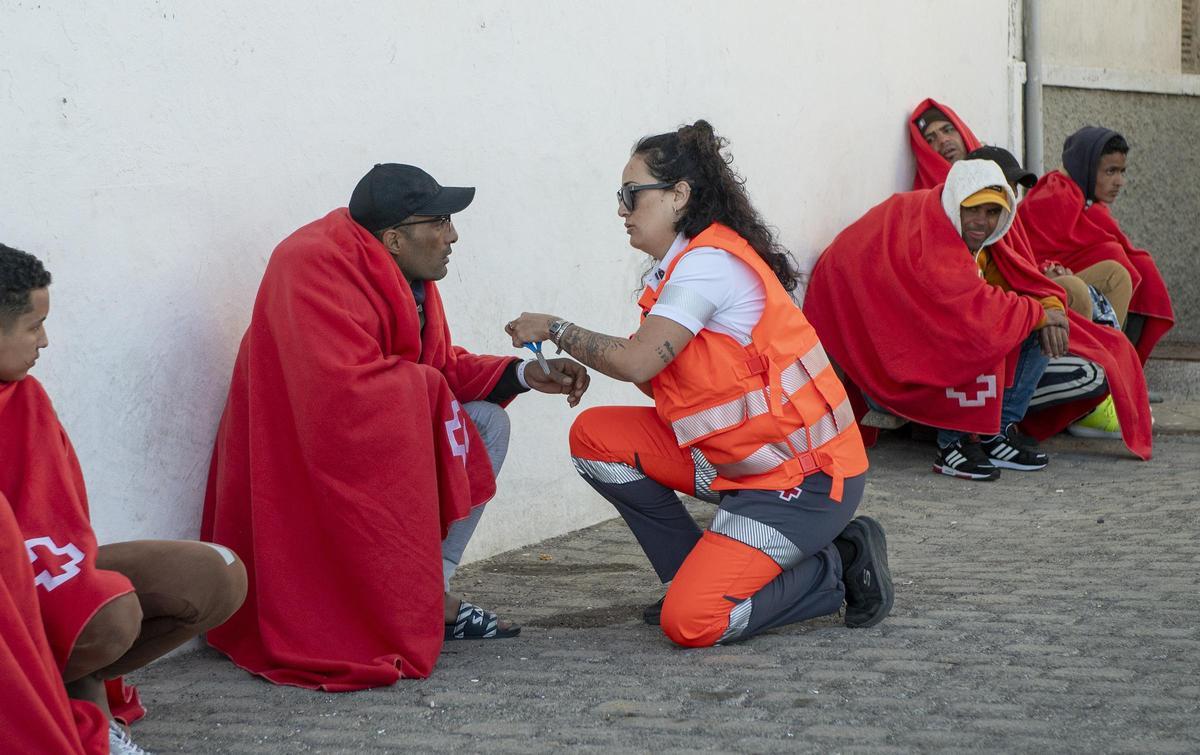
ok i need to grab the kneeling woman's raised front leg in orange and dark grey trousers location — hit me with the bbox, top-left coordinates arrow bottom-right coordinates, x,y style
570,407 -> 716,582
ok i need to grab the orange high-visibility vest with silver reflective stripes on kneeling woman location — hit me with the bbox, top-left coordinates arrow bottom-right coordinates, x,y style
637,223 -> 868,501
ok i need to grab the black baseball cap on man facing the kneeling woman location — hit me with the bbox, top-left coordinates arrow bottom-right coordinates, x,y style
350,162 -> 475,233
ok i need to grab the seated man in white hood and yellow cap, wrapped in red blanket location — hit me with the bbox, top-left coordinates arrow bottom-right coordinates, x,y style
804,160 -> 1148,480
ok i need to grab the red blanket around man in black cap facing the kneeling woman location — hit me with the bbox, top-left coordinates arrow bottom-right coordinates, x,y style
203,209 -> 511,691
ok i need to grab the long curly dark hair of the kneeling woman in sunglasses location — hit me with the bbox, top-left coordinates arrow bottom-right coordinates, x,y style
634,120 -> 798,292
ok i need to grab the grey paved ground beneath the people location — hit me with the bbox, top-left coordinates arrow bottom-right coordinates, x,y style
126,415 -> 1200,754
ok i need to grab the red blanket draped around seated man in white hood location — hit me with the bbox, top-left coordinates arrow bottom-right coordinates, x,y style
804,186 -> 1150,457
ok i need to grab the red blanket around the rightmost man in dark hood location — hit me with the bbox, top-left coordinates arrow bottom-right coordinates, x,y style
1020,172 -> 1175,362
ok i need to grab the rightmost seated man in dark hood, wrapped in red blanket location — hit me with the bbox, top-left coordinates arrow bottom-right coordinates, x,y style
1021,126 -> 1175,364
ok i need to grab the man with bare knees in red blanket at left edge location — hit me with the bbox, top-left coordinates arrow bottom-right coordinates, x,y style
0,245 -> 246,753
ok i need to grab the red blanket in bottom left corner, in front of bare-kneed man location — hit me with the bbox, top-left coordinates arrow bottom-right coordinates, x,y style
0,493 -> 108,754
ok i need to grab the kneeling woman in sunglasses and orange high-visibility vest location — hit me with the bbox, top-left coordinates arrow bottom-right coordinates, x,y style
505,120 -> 893,647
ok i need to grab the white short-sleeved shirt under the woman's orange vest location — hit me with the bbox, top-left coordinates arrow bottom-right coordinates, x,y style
646,233 -> 767,346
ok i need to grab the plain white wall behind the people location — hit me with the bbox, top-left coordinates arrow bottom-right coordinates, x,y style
0,0 -> 1009,557
